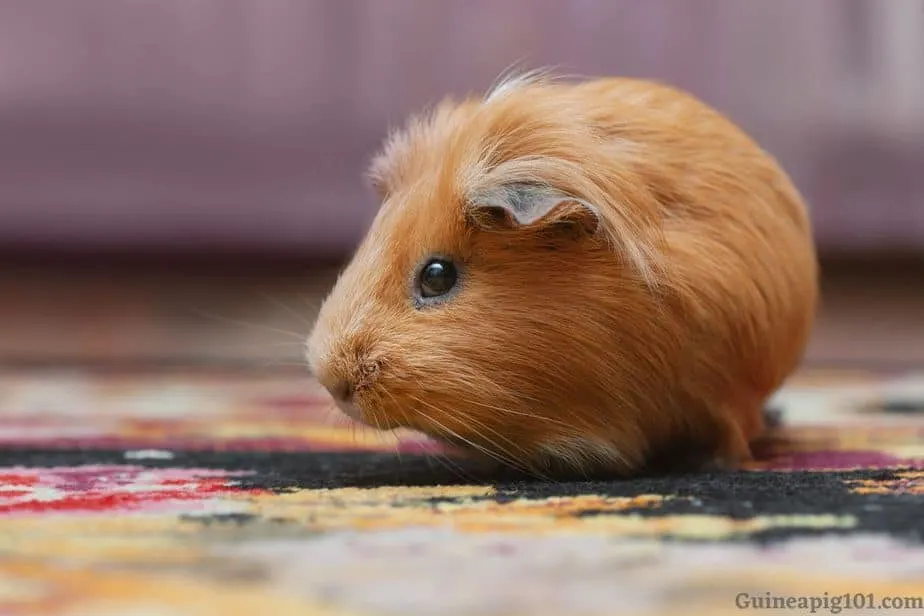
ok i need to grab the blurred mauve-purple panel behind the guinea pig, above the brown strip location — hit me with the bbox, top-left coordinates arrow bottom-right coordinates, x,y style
0,0 -> 924,253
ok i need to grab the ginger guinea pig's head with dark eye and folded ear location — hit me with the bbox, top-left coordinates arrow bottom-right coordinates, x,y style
308,79 -> 657,470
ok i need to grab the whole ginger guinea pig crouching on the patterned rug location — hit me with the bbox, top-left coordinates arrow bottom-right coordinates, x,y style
308,73 -> 818,475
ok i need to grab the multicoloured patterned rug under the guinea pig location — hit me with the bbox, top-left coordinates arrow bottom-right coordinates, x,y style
0,371 -> 924,616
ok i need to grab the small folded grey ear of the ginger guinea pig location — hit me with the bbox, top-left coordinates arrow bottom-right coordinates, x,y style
469,184 -> 600,235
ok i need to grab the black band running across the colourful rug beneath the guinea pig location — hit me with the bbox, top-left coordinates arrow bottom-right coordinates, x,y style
0,449 -> 924,542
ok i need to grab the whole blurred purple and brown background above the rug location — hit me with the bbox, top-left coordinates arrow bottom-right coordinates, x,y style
0,0 -> 924,365
